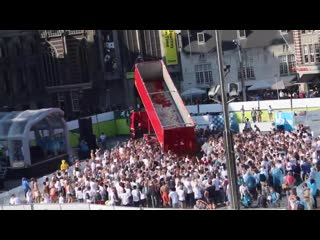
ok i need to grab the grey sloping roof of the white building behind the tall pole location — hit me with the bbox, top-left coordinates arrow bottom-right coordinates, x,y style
181,30 -> 293,54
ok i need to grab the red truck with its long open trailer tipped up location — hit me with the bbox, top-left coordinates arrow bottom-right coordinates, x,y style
130,61 -> 196,153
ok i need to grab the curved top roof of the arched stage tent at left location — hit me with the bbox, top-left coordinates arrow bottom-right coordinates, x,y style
0,108 -> 65,139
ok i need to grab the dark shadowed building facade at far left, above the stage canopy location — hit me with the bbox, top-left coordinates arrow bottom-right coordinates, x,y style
0,30 -> 50,111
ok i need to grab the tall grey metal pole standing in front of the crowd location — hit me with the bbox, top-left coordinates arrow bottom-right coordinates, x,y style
215,30 -> 240,210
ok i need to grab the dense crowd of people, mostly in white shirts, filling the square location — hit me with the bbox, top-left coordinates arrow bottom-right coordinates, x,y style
10,125 -> 320,209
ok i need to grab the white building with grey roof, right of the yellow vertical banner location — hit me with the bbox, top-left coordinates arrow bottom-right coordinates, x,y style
181,30 -> 296,100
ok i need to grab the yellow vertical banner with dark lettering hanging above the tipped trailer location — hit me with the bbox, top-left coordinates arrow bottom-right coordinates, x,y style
162,30 -> 178,65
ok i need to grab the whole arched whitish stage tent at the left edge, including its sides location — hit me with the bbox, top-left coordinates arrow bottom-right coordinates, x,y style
0,108 -> 70,167
